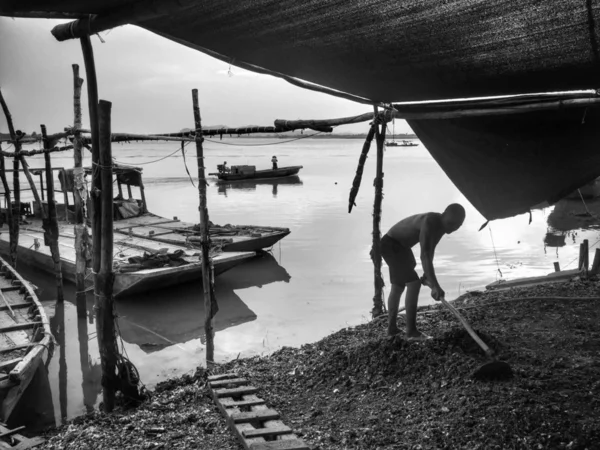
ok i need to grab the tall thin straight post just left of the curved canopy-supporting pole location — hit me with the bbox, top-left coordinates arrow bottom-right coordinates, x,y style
72,64 -> 90,318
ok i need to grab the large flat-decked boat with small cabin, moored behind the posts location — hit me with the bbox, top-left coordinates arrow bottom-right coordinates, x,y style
0,166 -> 260,296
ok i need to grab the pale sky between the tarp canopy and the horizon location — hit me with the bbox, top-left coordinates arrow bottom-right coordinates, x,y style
0,17 -> 410,137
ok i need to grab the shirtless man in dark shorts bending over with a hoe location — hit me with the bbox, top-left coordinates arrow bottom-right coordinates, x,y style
381,203 -> 465,340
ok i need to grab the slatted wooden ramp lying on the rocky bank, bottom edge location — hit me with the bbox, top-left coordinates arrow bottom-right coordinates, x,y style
208,373 -> 310,450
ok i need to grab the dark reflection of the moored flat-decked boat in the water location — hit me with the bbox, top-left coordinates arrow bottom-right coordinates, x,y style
116,252 -> 291,353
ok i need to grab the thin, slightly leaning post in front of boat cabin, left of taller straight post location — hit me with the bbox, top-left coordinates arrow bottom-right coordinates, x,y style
41,125 -> 64,302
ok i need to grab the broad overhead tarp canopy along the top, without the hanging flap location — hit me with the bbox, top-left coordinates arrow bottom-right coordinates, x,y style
0,0 -> 600,102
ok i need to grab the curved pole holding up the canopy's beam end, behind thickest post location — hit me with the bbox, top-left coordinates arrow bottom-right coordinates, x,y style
80,36 -> 102,282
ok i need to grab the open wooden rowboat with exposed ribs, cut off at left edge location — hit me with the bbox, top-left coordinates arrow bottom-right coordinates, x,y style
0,258 -> 53,423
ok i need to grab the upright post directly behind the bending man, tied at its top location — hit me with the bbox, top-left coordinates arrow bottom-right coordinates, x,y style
371,106 -> 386,317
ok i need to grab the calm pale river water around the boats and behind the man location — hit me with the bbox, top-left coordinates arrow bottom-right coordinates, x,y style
5,138 -> 599,428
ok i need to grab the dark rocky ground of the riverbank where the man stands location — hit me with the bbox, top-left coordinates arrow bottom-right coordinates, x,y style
42,280 -> 600,450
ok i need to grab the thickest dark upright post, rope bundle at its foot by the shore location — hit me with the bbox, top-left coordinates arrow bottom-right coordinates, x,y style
92,100 -> 119,412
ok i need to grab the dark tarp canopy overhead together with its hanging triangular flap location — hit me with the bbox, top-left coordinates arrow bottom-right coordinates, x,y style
0,0 -> 600,219
